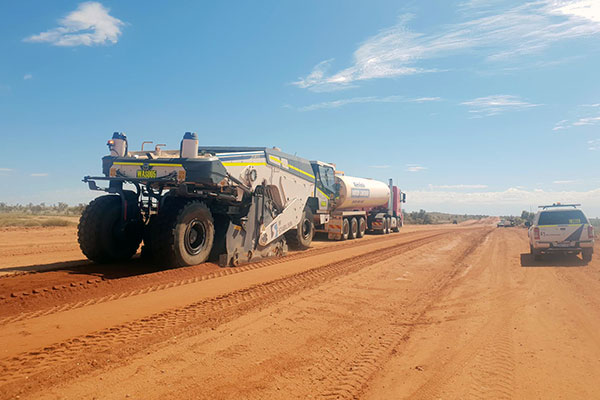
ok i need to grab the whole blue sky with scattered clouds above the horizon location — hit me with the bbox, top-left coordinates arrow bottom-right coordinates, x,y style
0,0 -> 600,216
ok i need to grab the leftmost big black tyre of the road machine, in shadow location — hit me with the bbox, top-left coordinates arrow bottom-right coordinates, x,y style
77,195 -> 143,263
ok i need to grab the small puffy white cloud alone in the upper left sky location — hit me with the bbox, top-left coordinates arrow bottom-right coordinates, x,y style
23,1 -> 124,46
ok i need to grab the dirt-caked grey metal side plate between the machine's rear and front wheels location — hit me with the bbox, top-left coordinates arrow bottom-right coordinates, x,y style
219,191 -> 288,267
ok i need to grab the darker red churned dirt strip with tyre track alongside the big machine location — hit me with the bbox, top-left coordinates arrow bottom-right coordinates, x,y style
0,229 -> 449,325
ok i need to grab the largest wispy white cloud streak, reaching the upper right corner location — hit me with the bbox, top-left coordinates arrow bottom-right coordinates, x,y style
293,0 -> 600,91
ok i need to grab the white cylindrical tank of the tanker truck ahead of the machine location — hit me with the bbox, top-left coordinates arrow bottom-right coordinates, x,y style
334,175 -> 390,210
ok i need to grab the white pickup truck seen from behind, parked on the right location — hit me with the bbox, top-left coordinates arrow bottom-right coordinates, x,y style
528,204 -> 594,262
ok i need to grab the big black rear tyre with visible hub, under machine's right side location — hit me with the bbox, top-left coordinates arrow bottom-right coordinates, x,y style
150,200 -> 215,267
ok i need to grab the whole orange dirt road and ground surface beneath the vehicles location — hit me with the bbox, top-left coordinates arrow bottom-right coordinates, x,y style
0,221 -> 600,400
